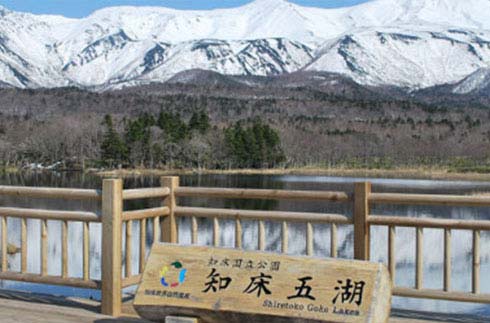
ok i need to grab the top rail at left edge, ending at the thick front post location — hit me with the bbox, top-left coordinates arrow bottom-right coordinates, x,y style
0,185 -> 102,200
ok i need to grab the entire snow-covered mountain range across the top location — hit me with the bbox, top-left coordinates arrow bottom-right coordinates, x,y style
0,0 -> 490,89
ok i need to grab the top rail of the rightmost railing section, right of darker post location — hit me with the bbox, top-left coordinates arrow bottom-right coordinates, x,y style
368,193 -> 490,206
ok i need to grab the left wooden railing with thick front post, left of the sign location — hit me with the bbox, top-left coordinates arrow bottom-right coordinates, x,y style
0,179 -> 169,316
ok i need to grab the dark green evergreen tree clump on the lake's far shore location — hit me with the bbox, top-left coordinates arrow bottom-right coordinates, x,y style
98,110 -> 286,169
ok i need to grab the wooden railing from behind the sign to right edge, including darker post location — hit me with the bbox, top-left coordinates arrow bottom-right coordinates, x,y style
171,182 -> 490,303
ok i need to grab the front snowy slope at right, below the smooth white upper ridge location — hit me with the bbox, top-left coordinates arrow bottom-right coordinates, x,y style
306,28 -> 490,88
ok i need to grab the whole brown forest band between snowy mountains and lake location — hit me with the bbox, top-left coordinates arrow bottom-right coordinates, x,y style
0,79 -> 490,172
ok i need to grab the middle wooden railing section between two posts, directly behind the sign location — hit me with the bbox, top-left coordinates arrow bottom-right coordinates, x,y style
171,183 -> 352,257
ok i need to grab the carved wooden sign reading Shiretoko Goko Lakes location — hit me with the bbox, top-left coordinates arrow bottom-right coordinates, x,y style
134,244 -> 391,323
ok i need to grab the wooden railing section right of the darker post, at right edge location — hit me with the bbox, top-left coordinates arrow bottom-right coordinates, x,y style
364,183 -> 490,303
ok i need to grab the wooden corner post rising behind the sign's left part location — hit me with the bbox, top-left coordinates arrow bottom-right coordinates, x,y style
161,176 -> 179,243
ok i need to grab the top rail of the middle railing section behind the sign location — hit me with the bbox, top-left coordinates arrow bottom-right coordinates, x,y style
175,186 -> 351,202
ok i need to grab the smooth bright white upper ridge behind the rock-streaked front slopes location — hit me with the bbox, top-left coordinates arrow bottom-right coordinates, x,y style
57,0 -> 490,44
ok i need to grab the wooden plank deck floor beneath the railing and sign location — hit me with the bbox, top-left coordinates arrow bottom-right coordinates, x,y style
0,290 -> 482,323
